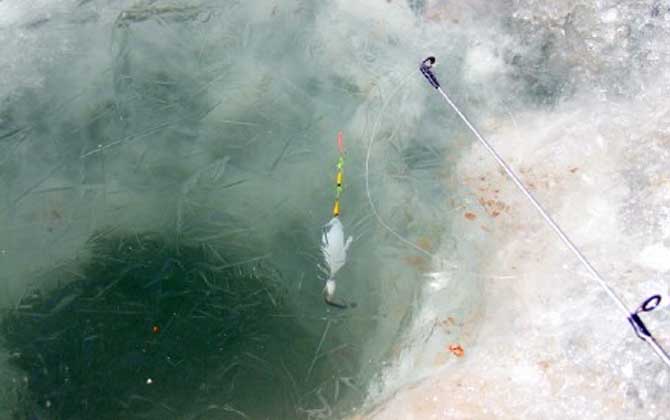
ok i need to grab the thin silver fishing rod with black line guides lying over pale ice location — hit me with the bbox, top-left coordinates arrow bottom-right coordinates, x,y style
419,56 -> 670,368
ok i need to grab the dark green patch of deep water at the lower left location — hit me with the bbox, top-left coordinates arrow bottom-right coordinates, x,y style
0,231 -> 355,420
